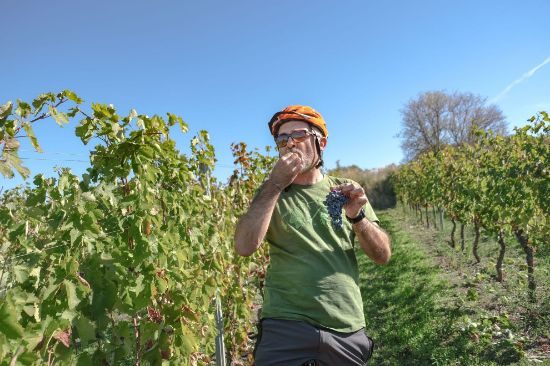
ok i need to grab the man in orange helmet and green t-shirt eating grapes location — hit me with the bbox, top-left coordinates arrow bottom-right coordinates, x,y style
235,106 -> 391,366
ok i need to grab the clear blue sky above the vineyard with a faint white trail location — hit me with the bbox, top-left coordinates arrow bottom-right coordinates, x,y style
0,0 -> 550,188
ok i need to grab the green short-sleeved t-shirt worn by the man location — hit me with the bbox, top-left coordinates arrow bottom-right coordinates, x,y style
262,175 -> 378,332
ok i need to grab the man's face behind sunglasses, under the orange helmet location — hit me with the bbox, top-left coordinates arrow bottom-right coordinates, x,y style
279,121 -> 326,173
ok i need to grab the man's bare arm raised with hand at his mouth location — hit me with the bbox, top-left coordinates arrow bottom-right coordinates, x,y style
235,153 -> 302,256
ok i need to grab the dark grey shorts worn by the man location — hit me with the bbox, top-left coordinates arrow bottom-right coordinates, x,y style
254,318 -> 374,366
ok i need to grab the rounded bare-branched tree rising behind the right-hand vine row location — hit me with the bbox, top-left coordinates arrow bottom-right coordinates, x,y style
399,91 -> 506,160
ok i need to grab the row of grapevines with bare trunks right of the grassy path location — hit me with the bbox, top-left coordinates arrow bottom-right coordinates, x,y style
394,112 -> 550,299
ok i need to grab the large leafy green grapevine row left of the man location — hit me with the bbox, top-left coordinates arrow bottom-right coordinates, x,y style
0,91 -> 274,365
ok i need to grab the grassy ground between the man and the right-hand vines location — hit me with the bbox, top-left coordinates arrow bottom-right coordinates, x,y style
358,209 -> 550,365
